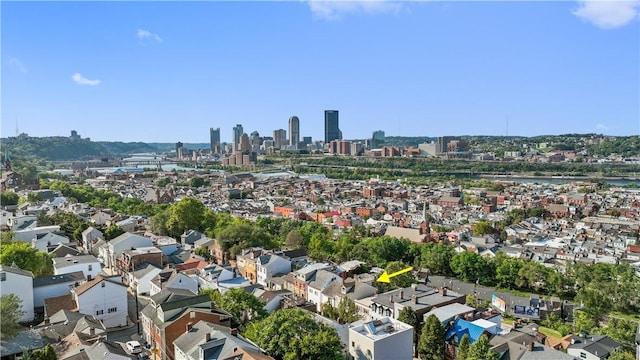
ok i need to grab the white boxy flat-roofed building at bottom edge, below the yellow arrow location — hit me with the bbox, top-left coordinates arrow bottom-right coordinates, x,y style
349,317 -> 413,360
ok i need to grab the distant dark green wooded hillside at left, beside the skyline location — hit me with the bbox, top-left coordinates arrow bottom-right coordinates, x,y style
0,134 -> 158,161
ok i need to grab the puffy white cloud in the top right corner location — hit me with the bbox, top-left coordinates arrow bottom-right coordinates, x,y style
573,0 -> 640,29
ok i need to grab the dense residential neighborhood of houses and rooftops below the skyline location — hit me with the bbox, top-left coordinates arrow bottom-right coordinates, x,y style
0,171 -> 640,360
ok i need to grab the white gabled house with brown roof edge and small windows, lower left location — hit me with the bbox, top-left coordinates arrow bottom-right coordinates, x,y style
71,275 -> 128,328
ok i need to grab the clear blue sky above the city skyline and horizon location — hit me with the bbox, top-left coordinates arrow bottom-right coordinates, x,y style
0,0 -> 640,142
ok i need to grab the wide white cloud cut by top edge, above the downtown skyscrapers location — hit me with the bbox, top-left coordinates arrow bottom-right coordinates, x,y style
308,0 -> 405,20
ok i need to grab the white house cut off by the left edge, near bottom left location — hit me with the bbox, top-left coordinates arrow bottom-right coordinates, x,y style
0,265 -> 34,322
